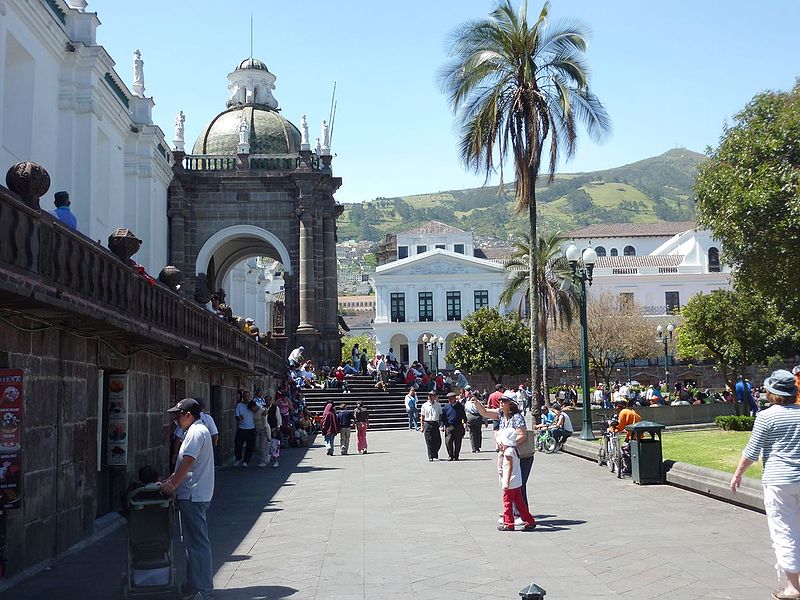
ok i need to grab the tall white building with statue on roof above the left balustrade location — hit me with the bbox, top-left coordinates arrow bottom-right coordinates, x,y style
0,0 -> 172,275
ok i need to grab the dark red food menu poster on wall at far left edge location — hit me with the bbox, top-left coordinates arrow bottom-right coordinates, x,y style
0,369 -> 24,509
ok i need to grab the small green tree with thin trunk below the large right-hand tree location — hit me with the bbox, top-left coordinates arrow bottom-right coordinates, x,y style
677,290 -> 797,415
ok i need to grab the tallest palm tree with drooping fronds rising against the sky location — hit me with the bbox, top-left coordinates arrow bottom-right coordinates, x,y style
441,0 -> 611,416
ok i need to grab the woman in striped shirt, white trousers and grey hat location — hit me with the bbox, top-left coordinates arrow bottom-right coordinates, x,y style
730,370 -> 800,600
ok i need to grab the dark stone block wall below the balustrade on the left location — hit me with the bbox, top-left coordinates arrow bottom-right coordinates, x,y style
0,321 -> 253,575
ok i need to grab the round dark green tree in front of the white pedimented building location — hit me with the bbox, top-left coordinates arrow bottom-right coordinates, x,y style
445,307 -> 530,383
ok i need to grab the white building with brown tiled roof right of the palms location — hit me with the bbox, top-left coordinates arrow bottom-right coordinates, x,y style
567,221 -> 731,315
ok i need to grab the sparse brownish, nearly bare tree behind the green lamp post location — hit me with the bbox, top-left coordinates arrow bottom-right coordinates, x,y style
551,294 -> 658,389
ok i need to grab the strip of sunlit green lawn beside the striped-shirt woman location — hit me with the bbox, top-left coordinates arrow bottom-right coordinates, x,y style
663,429 -> 761,479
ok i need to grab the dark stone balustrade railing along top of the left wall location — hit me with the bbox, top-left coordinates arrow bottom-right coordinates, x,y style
0,187 -> 284,374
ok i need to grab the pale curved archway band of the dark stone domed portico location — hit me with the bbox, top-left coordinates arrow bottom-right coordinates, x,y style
195,225 -> 292,287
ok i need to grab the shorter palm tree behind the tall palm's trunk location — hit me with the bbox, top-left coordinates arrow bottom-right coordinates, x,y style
500,232 -> 578,406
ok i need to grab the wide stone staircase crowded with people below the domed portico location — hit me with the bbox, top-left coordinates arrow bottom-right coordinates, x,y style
303,375 -> 418,429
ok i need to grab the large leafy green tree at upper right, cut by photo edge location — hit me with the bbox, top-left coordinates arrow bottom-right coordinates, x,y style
695,81 -> 800,322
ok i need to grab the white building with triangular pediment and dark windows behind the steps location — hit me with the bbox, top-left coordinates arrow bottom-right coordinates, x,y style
373,221 -> 506,369
